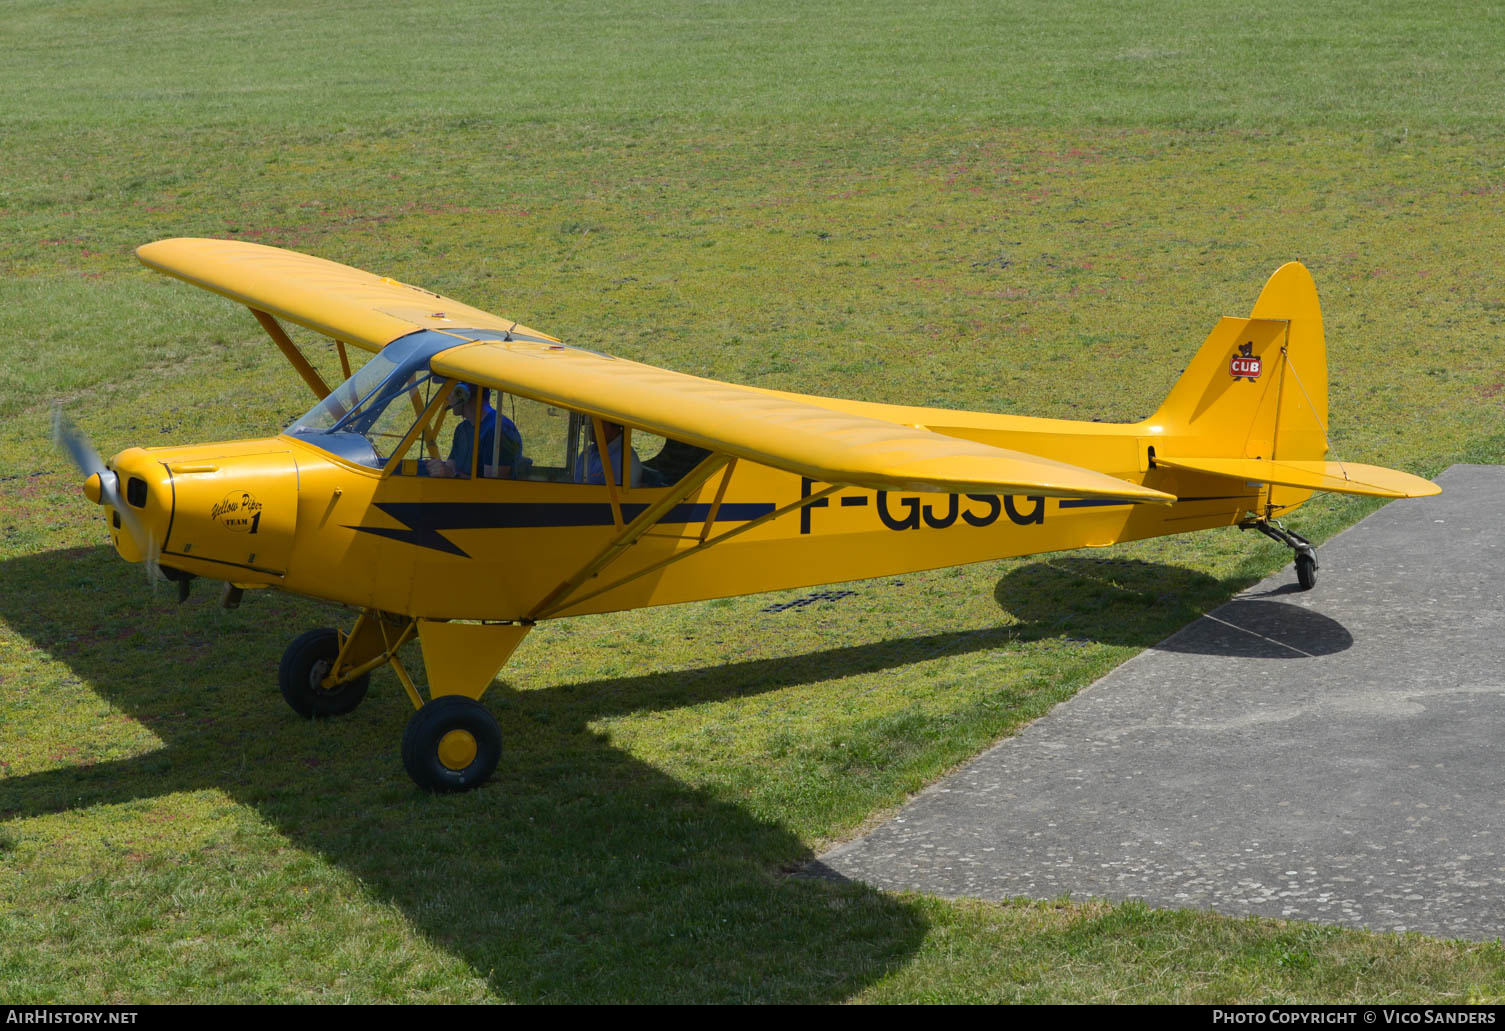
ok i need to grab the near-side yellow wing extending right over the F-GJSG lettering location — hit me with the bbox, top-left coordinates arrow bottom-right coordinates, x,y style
429,340 -> 1175,503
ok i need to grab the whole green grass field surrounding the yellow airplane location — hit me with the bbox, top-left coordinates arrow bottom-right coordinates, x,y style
0,0 -> 1505,1002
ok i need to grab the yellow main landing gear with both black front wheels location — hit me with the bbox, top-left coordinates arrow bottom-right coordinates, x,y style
277,610 -> 531,792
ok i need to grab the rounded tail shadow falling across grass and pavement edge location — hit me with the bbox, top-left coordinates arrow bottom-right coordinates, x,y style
993,555 -> 1353,659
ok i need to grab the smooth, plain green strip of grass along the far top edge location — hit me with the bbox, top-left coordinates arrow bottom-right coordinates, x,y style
0,0 -> 1505,134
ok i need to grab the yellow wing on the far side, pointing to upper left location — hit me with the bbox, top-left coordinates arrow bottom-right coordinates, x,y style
135,239 -> 552,351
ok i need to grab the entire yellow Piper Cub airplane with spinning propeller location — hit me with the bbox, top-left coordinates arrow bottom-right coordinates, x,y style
57,239 -> 1439,792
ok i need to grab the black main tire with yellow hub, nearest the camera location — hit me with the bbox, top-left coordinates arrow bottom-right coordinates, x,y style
402,694 -> 501,792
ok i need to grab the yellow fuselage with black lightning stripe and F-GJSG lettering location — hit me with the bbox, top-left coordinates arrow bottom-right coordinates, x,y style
100,399 -> 1269,620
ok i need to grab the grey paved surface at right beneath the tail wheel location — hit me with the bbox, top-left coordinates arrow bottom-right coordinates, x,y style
810,465 -> 1505,941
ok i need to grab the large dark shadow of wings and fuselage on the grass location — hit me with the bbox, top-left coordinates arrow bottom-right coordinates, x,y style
0,548 -> 1004,1001
